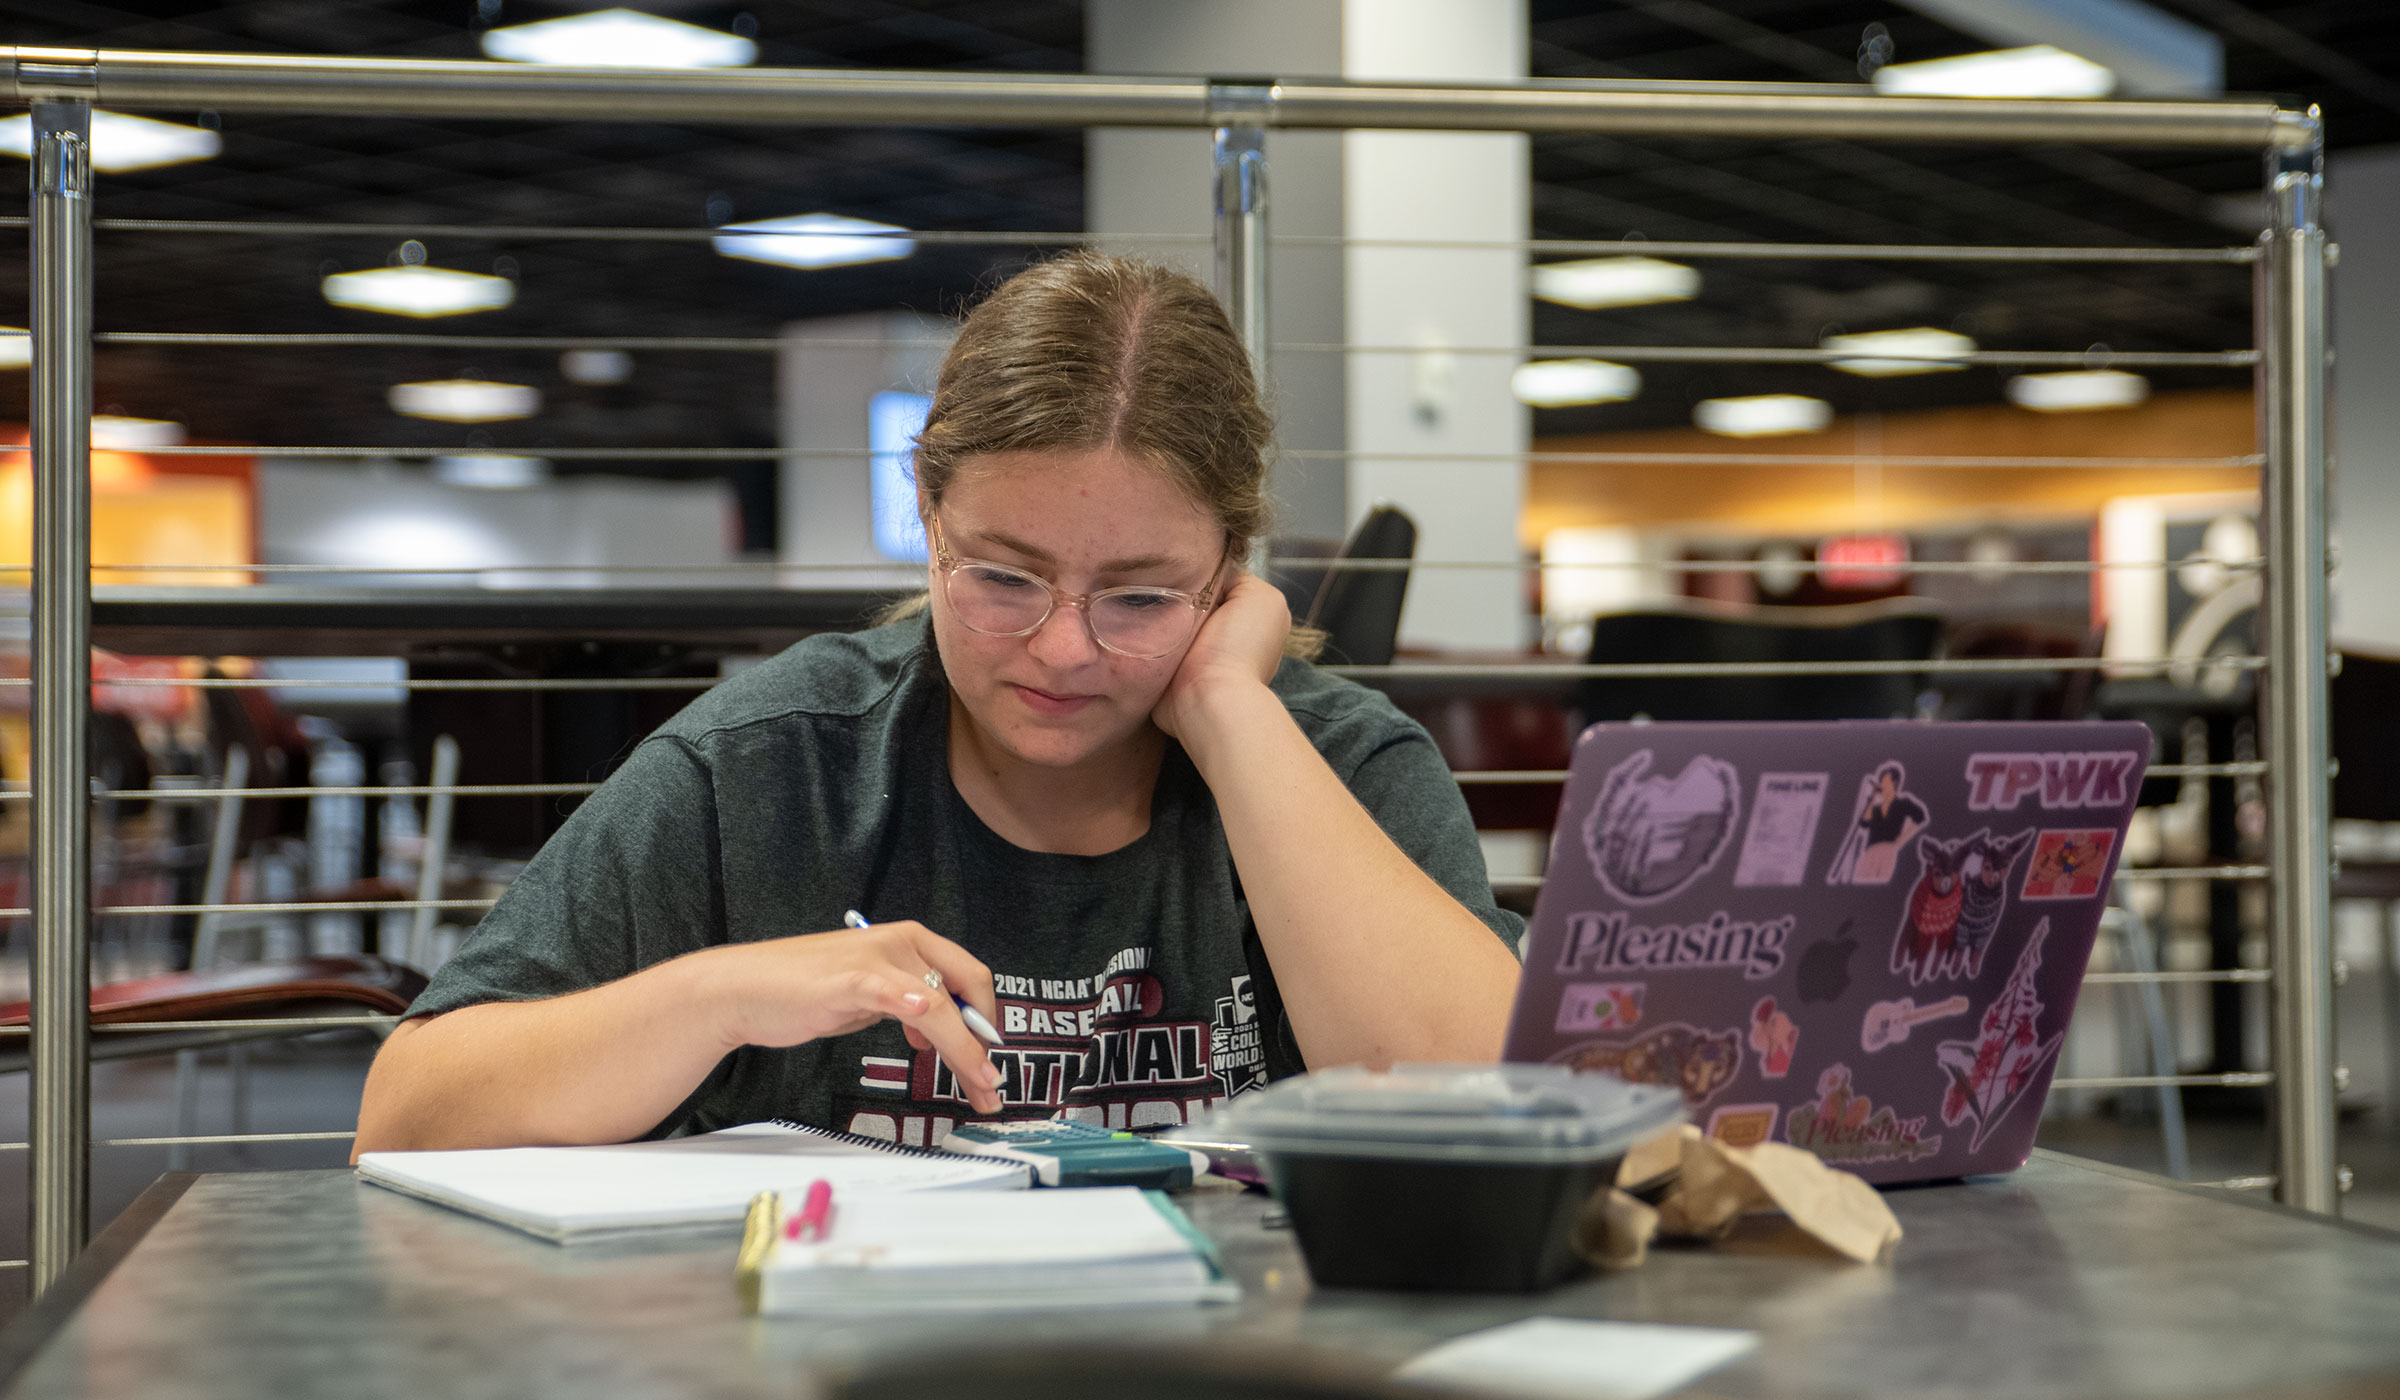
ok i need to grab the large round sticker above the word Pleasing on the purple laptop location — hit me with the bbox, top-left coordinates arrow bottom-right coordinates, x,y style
1584,749 -> 1742,905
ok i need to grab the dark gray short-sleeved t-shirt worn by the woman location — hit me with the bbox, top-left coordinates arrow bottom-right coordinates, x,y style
410,620 -> 1524,1145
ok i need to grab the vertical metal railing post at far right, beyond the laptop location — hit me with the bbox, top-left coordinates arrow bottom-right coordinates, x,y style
2258,108 -> 2340,1215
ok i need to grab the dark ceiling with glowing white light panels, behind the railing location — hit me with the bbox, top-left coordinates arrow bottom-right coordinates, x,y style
0,0 -> 2400,545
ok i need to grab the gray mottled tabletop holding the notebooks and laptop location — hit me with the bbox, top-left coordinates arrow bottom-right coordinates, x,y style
0,1153 -> 2400,1400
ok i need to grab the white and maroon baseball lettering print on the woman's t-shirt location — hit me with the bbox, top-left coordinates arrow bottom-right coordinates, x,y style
835,949 -> 1267,1145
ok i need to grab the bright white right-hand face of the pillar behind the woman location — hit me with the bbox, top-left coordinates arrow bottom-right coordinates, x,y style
1344,0 -> 1531,651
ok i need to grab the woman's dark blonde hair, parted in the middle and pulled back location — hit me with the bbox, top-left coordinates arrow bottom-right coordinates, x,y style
886,252 -> 1322,658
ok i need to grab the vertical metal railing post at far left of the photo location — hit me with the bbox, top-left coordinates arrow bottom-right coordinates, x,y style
29,101 -> 91,1294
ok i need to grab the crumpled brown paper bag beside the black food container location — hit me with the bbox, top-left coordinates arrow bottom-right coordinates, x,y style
1574,1124 -> 1901,1268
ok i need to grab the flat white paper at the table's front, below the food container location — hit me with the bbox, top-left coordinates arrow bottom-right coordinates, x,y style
1392,1318 -> 1759,1400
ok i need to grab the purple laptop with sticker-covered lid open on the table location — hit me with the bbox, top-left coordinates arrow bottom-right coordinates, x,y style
1505,720 -> 2150,1181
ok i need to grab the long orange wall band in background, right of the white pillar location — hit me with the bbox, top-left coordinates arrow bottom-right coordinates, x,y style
1519,389 -> 2258,550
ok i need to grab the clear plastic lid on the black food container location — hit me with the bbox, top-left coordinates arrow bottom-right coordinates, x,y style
1166,1064 -> 1685,1167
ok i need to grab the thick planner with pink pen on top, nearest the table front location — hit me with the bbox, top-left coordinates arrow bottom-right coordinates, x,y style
737,1186 -> 1241,1314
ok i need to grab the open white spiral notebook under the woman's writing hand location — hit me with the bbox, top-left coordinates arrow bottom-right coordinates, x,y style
358,1124 -> 1032,1244
